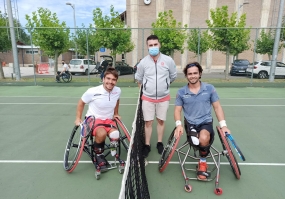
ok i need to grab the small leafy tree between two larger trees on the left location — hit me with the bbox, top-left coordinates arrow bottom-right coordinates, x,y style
74,24 -> 100,55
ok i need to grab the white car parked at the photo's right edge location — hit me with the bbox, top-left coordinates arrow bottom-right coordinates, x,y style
246,61 -> 285,79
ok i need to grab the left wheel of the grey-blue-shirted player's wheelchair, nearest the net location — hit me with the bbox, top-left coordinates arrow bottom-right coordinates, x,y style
158,128 -> 181,172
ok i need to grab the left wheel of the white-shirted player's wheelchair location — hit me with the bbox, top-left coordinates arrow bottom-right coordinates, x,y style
63,126 -> 86,173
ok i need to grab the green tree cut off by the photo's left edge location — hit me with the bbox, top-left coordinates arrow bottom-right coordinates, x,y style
0,11 -> 12,79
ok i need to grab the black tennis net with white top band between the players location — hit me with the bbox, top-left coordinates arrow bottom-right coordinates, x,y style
119,87 -> 150,199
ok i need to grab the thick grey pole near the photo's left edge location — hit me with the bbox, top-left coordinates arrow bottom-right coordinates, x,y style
7,0 -> 21,81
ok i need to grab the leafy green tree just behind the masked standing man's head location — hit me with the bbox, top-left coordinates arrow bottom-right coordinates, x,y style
151,10 -> 187,57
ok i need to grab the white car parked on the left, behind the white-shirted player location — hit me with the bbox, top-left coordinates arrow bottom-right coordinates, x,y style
69,59 -> 98,75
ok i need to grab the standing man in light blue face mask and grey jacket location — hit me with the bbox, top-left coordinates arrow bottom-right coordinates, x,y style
135,35 -> 177,158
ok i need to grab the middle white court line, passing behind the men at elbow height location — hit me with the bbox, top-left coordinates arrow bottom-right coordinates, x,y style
0,103 -> 285,107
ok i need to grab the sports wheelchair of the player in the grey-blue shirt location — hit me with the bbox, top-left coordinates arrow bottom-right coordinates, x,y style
158,126 -> 241,195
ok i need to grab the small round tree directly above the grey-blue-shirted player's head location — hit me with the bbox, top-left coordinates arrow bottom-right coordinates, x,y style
187,29 -> 211,62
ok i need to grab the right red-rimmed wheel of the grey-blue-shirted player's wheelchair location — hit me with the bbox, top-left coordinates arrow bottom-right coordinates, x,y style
216,126 -> 241,179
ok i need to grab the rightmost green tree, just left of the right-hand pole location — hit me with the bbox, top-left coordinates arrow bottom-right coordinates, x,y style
255,29 -> 276,60
